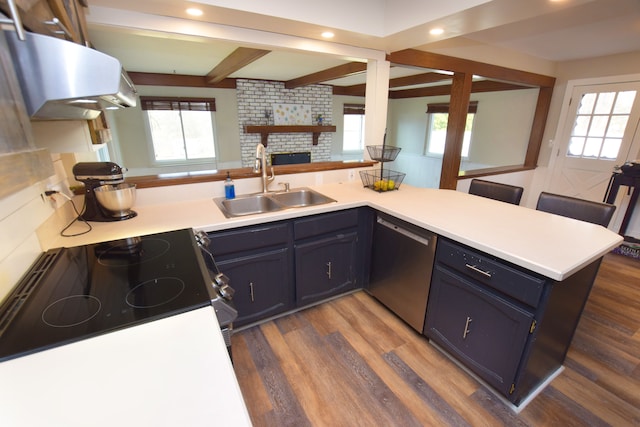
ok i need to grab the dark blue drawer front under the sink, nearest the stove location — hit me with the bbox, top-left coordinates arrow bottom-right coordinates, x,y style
209,223 -> 289,256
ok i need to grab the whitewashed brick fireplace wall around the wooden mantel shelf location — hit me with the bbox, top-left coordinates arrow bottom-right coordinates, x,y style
236,79 -> 333,167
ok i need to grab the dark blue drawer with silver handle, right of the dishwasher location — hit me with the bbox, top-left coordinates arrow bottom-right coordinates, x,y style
436,239 -> 545,307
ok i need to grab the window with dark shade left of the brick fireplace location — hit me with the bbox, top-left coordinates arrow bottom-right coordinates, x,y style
140,97 -> 216,163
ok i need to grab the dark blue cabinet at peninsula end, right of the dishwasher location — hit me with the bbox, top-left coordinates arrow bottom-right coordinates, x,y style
424,238 -> 601,405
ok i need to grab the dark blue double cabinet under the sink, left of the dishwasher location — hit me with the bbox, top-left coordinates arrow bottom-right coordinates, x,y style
208,208 -> 373,327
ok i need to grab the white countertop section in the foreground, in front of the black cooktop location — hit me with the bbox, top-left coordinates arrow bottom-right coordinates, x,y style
0,307 -> 251,427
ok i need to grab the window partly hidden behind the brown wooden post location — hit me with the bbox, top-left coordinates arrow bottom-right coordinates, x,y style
425,101 -> 478,157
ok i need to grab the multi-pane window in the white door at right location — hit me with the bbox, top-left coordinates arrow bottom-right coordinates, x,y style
567,90 -> 636,160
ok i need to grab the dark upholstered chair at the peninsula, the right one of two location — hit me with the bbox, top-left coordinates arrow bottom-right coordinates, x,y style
536,191 -> 616,227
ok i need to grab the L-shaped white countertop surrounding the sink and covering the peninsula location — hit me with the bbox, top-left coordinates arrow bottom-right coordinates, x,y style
41,181 -> 622,280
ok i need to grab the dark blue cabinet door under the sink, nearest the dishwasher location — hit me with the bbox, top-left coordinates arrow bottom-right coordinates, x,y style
295,231 -> 358,306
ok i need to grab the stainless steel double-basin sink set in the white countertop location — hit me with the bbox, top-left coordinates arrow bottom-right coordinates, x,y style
214,187 -> 335,218
